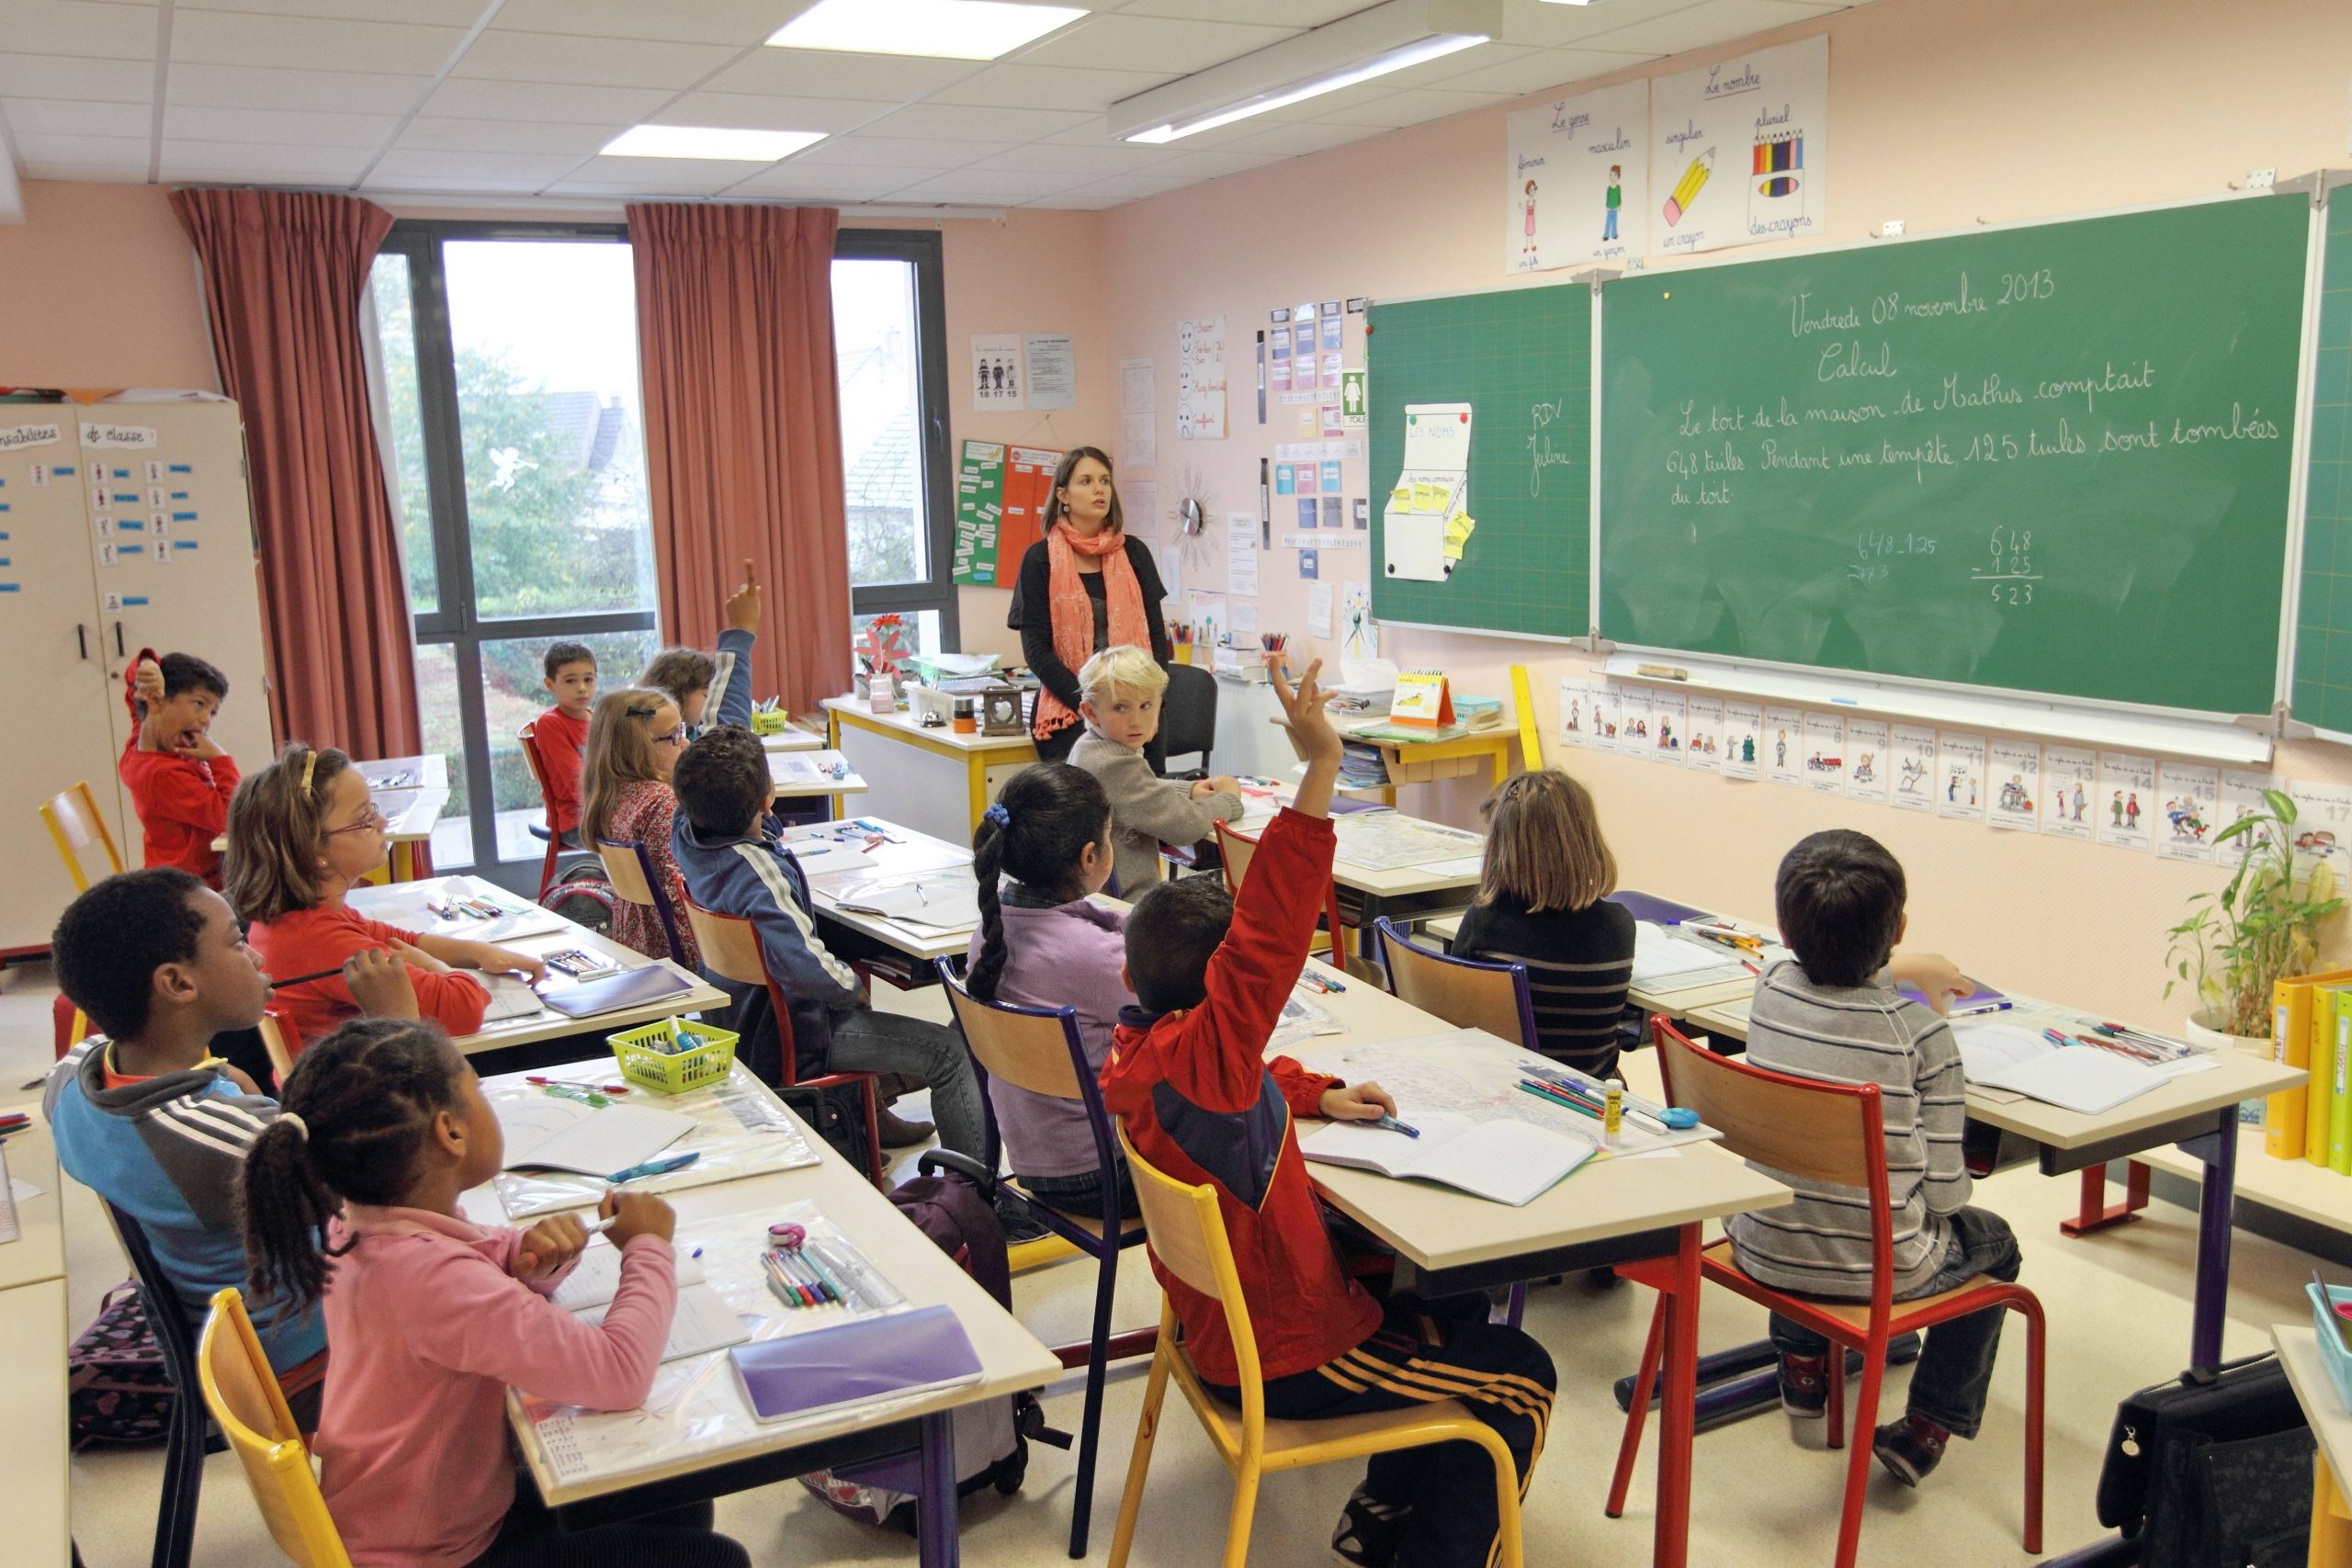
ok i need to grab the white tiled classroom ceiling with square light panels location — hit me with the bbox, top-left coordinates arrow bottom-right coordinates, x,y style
0,0 -> 1856,216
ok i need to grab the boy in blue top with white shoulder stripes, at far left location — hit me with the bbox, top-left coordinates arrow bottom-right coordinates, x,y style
42,867 -> 416,1432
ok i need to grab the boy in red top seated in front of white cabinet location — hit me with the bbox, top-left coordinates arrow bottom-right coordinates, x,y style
115,649 -> 238,886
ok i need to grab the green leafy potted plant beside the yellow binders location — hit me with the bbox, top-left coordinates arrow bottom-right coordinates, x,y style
2164,790 -> 2345,1034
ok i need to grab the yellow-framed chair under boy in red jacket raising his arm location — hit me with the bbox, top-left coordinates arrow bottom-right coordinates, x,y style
1110,1128 -> 1526,1568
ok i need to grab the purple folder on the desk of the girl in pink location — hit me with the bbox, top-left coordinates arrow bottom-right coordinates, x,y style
727,1307 -> 981,1420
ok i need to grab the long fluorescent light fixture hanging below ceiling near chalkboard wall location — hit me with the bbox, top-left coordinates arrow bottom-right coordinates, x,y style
1105,0 -> 1503,143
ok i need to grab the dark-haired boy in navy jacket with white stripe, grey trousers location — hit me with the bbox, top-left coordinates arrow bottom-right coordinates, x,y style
671,727 -> 988,1159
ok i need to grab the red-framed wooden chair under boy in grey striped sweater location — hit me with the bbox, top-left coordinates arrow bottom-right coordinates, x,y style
1609,1013 -> 2046,1568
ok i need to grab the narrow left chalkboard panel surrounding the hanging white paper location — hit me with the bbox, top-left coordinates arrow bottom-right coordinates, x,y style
1364,285 -> 1592,637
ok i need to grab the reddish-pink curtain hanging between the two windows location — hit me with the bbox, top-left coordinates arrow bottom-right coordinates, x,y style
628,202 -> 849,712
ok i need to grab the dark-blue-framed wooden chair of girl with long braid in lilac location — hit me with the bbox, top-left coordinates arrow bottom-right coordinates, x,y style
933,959 -> 1158,1556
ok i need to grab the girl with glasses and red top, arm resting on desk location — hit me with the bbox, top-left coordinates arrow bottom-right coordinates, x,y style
226,740 -> 548,1042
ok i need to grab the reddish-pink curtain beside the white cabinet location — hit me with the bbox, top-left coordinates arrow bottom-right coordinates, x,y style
172,190 -> 421,766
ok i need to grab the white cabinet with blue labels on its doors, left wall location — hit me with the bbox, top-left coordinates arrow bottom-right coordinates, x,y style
0,402 -> 273,957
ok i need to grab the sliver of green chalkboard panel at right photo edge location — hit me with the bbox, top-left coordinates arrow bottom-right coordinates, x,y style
2290,186 -> 2352,733
